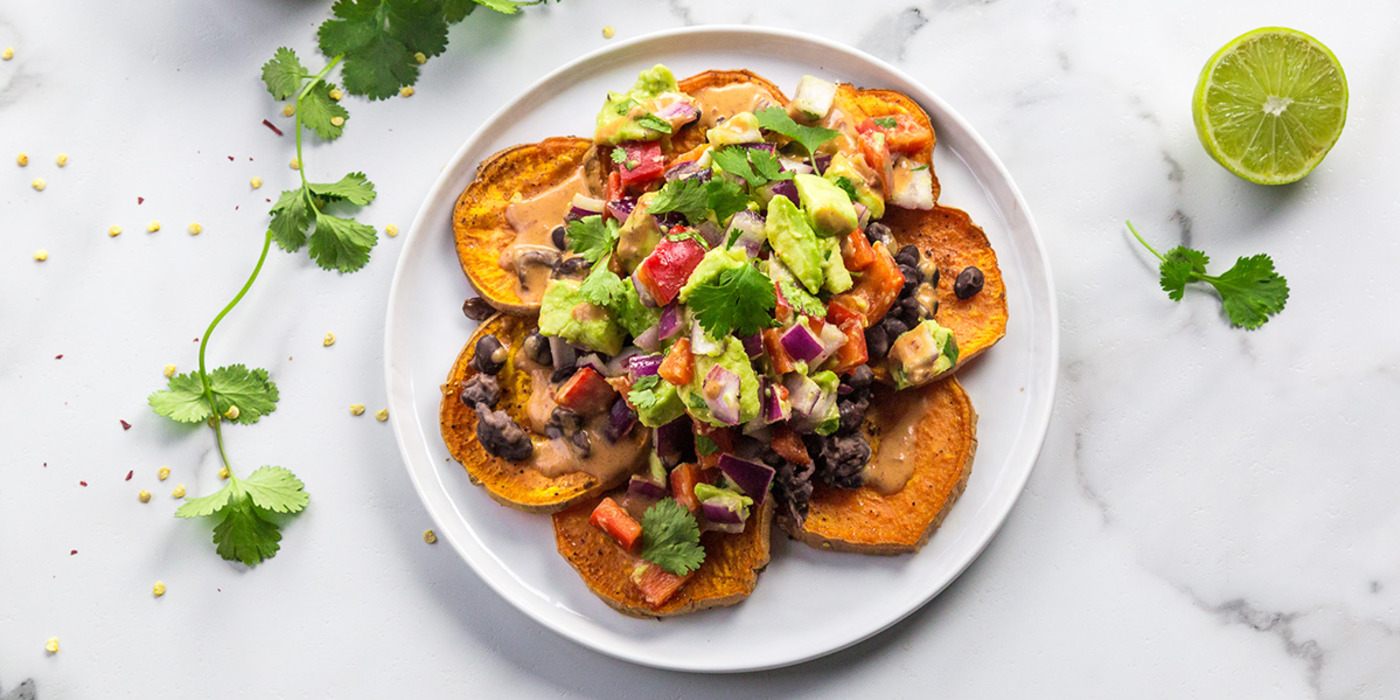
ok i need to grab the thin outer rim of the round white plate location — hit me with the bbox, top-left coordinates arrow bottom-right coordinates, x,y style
382,24 -> 1060,672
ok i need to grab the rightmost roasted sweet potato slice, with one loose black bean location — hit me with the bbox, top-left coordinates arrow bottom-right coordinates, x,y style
883,206 -> 1007,371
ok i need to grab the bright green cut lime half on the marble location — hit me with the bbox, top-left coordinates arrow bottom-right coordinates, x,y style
1191,27 -> 1347,185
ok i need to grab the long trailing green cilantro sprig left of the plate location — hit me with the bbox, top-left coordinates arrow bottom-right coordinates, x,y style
147,0 -> 551,566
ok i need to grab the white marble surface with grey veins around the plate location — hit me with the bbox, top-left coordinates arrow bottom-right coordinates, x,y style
0,0 -> 1400,700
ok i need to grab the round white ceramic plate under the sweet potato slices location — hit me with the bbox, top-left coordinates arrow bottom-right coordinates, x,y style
385,27 -> 1058,671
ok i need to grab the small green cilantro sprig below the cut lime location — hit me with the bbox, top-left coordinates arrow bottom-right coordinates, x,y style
1126,221 -> 1288,330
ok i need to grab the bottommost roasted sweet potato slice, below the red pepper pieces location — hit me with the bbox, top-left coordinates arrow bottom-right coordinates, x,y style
554,496 -> 773,617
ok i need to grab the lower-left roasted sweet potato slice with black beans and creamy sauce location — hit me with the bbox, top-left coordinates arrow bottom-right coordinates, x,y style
440,314 -> 651,512
